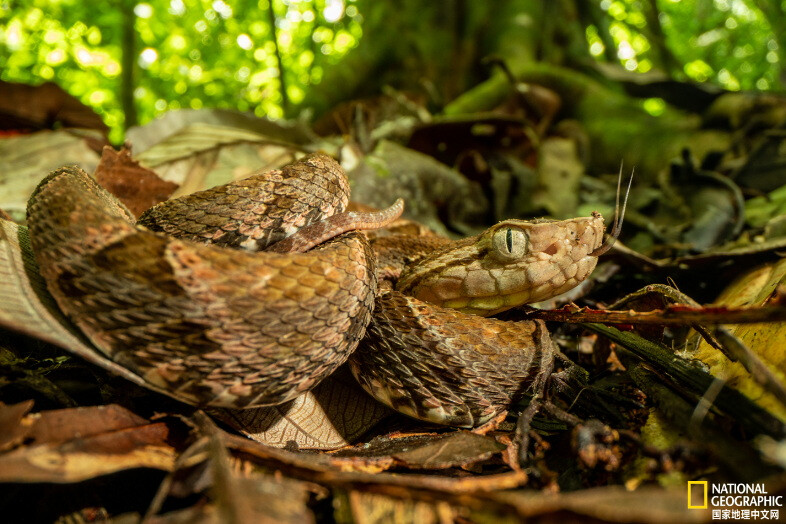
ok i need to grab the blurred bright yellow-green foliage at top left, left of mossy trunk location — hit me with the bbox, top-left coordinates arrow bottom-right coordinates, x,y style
0,0 -> 362,142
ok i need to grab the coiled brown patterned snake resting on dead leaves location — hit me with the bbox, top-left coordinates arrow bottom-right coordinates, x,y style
27,153 -> 606,428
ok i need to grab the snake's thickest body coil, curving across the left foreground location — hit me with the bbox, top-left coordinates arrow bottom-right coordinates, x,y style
28,162 -> 376,407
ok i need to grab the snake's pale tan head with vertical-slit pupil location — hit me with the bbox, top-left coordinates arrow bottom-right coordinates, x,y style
396,213 -> 605,316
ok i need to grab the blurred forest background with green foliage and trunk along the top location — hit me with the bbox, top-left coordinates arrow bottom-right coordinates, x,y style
0,0 -> 786,142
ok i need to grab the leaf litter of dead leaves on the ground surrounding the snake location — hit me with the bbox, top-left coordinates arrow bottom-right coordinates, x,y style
0,84 -> 786,522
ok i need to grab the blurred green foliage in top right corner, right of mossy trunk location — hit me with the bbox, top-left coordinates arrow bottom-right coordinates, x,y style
587,0 -> 786,91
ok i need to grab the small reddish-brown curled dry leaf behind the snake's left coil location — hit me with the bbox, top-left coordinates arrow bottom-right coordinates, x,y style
95,146 -> 177,218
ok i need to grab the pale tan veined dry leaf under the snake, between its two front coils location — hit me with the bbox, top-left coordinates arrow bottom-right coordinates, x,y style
211,368 -> 393,450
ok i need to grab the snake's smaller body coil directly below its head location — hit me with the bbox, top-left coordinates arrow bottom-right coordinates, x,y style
349,290 -> 554,428
